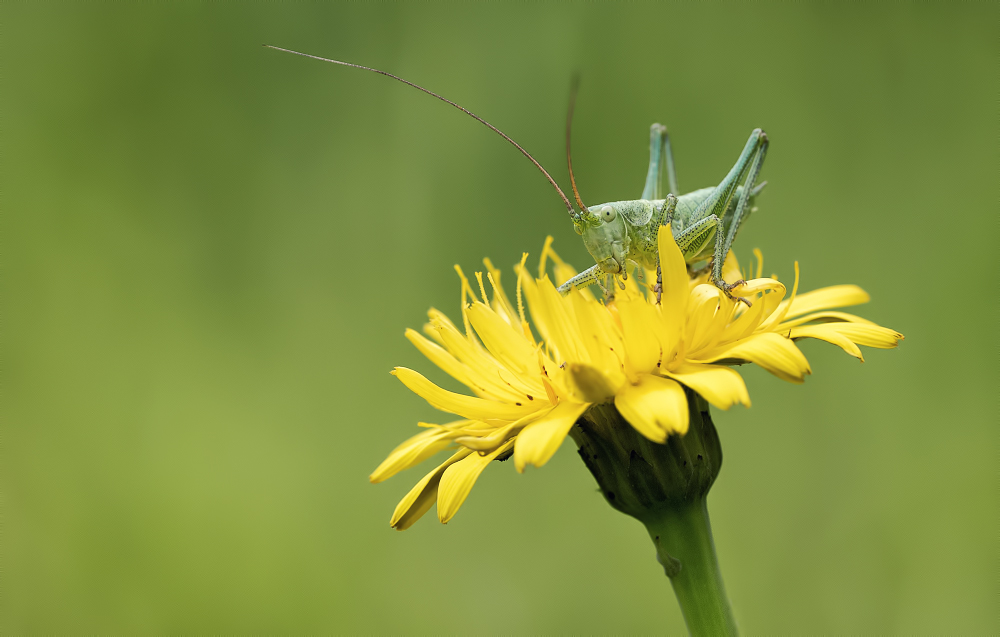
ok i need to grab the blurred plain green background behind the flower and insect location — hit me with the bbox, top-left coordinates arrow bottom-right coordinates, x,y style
0,2 -> 1000,634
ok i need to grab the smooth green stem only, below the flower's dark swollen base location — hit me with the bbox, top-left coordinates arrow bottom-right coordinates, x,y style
645,499 -> 738,635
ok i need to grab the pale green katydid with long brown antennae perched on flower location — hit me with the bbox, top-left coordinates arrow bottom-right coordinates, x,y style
264,45 -> 768,305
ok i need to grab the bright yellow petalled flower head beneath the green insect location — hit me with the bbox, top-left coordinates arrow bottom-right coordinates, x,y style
370,230 -> 903,530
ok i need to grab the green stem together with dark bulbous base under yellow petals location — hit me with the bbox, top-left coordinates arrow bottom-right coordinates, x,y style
570,389 -> 737,635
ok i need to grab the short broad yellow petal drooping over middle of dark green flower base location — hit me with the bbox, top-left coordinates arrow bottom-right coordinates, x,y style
615,374 -> 688,442
